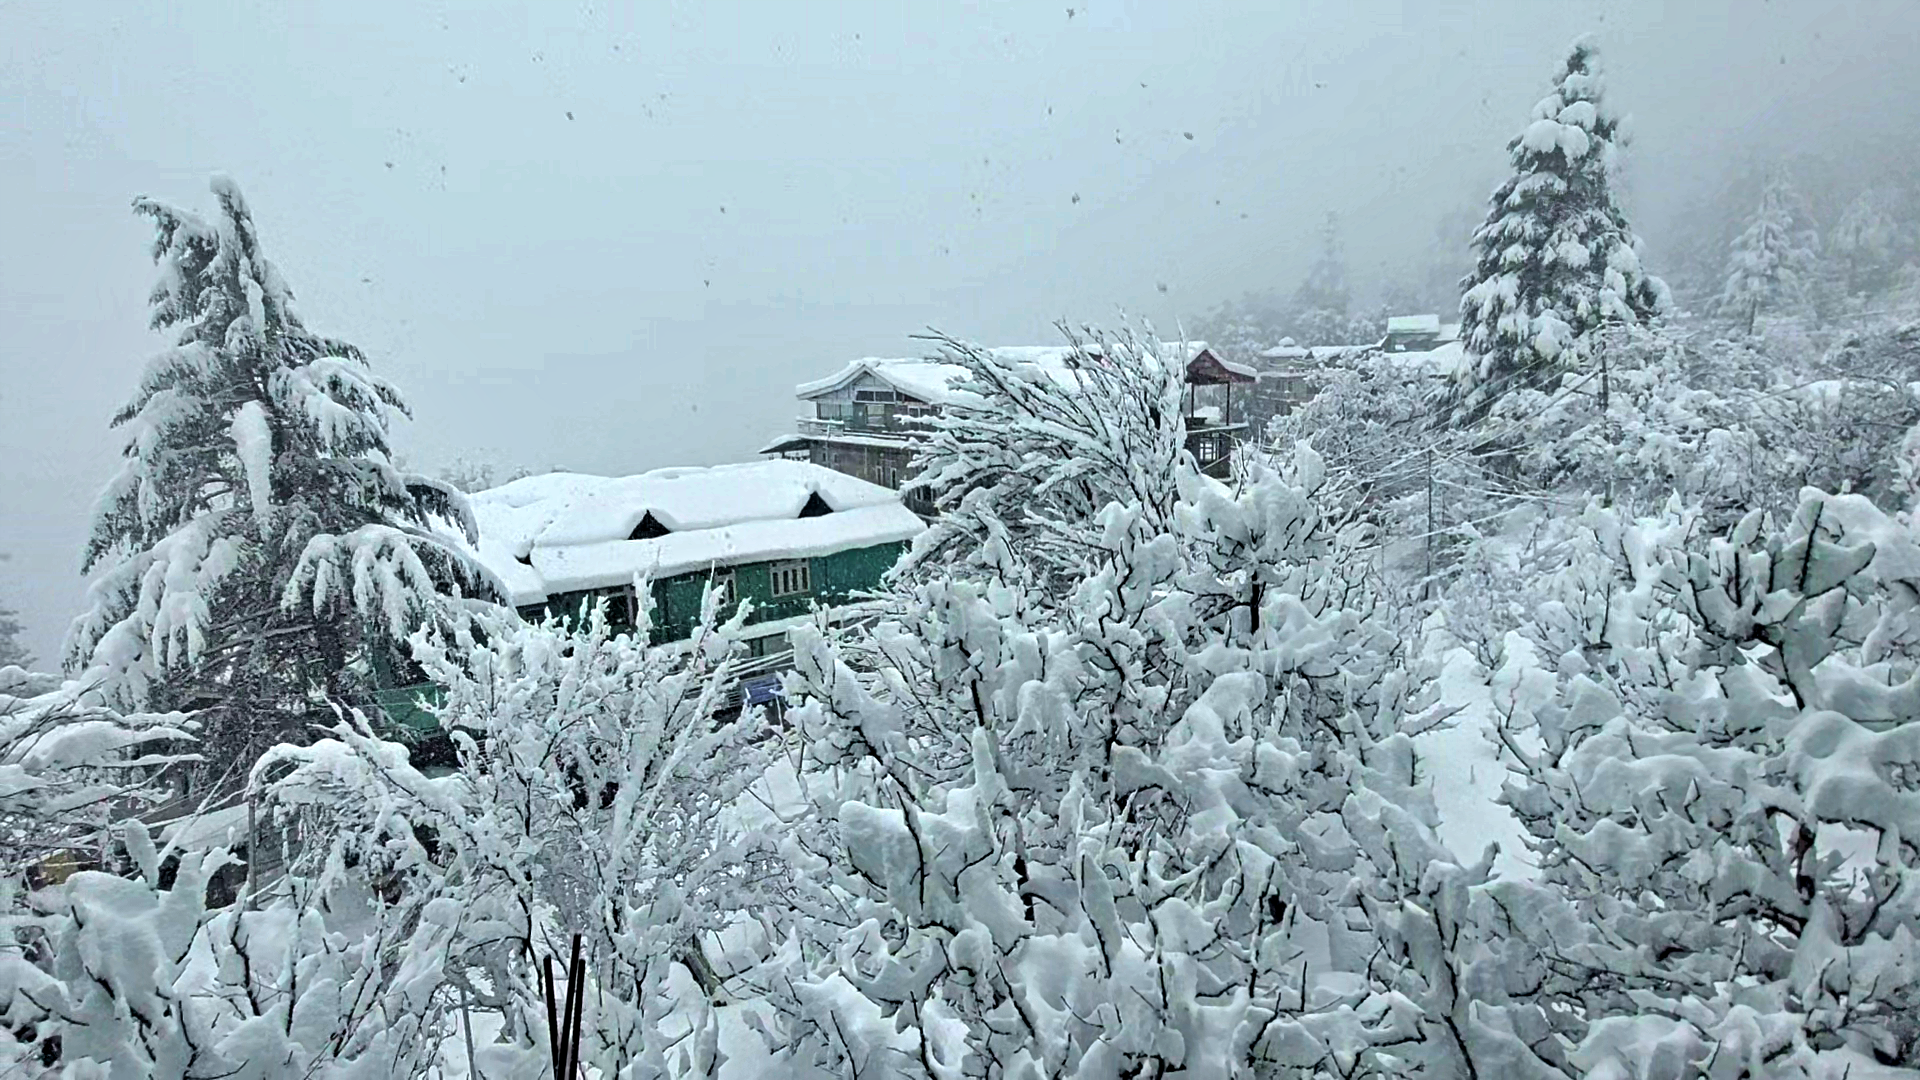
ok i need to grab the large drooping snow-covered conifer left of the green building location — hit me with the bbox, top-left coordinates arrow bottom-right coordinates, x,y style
65,177 -> 495,780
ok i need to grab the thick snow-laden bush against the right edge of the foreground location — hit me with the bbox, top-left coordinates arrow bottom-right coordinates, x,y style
1507,492 -> 1920,1076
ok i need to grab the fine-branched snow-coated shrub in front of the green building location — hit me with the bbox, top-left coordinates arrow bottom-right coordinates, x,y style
257,588 -> 781,1076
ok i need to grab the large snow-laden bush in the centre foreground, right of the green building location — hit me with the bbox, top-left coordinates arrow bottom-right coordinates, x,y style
747,319 -> 1466,1076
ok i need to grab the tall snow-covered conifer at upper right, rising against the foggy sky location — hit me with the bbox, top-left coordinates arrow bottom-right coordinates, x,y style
1452,40 -> 1667,423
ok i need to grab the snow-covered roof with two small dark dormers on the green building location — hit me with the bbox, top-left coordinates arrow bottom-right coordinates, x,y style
453,461 -> 925,607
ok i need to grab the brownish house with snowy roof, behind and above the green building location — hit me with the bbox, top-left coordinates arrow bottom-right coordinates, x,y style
760,342 -> 1252,517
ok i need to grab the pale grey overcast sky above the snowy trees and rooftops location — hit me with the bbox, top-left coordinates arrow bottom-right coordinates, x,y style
0,0 -> 1920,665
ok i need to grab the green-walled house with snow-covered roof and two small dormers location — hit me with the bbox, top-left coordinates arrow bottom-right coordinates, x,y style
456,461 -> 924,655
